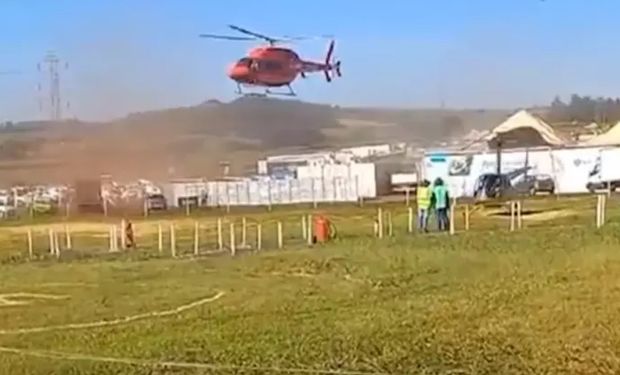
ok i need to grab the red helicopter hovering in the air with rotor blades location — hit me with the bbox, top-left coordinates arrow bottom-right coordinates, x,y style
200,25 -> 342,96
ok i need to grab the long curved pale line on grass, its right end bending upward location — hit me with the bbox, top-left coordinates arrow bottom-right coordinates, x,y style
0,292 -> 225,335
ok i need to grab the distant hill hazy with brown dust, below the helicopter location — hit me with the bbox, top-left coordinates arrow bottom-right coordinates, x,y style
0,97 -> 509,182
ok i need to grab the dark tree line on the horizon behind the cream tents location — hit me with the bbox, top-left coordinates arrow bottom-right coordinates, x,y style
546,94 -> 620,124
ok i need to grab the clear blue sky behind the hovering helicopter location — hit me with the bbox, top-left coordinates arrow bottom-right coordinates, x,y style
0,0 -> 620,121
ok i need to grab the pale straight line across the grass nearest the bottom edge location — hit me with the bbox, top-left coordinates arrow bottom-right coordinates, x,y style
0,346 -> 387,375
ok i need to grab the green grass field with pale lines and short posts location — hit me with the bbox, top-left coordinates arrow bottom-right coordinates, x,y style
0,197 -> 620,374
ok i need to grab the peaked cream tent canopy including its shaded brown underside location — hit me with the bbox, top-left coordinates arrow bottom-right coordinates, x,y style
487,110 -> 566,147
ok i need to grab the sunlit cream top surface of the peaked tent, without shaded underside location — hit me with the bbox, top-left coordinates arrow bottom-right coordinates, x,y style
487,110 -> 566,146
